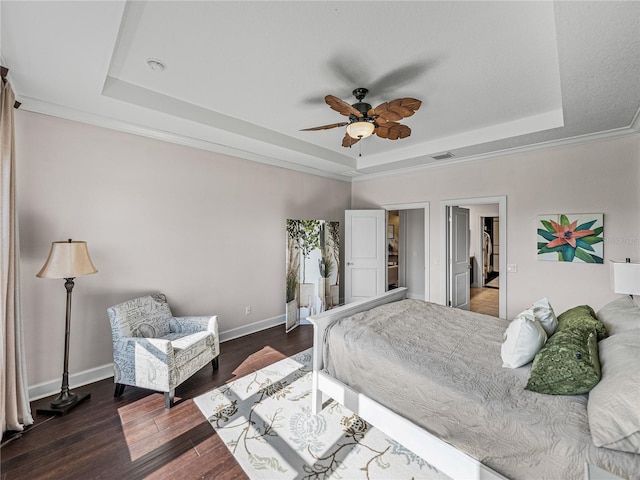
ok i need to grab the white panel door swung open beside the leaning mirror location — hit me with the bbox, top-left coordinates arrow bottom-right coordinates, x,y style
344,210 -> 387,303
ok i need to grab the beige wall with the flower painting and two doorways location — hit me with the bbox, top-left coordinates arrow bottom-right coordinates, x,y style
352,135 -> 640,318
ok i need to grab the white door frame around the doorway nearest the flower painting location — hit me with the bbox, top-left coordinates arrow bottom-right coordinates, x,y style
440,195 -> 507,318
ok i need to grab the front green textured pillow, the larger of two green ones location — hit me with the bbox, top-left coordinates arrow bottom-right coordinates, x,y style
525,328 -> 600,395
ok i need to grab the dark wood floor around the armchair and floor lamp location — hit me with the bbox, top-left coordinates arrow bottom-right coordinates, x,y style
0,326 -> 313,480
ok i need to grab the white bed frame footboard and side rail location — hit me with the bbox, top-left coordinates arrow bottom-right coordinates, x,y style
308,288 -> 506,480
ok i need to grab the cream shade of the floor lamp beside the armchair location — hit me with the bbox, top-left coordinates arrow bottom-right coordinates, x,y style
36,239 -> 98,278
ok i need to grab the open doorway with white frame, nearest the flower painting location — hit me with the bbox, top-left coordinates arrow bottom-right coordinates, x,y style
441,196 -> 507,318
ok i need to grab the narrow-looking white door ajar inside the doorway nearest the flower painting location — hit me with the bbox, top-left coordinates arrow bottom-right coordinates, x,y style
449,206 -> 470,310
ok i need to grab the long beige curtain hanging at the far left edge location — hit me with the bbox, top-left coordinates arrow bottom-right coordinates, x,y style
0,78 -> 33,433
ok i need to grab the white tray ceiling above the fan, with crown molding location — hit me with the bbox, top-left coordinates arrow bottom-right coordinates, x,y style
0,0 -> 640,179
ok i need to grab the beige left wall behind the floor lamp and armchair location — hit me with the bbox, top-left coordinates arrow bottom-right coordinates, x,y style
16,110 -> 351,393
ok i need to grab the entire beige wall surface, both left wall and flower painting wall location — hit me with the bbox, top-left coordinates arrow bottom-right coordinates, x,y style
16,110 -> 640,393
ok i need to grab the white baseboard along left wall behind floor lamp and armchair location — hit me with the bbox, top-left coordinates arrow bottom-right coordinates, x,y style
28,315 -> 288,402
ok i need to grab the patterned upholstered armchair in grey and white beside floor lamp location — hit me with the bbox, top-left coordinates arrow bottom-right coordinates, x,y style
107,294 -> 220,408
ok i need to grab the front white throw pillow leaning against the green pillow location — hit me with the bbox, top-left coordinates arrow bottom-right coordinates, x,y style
500,307 -> 547,368
